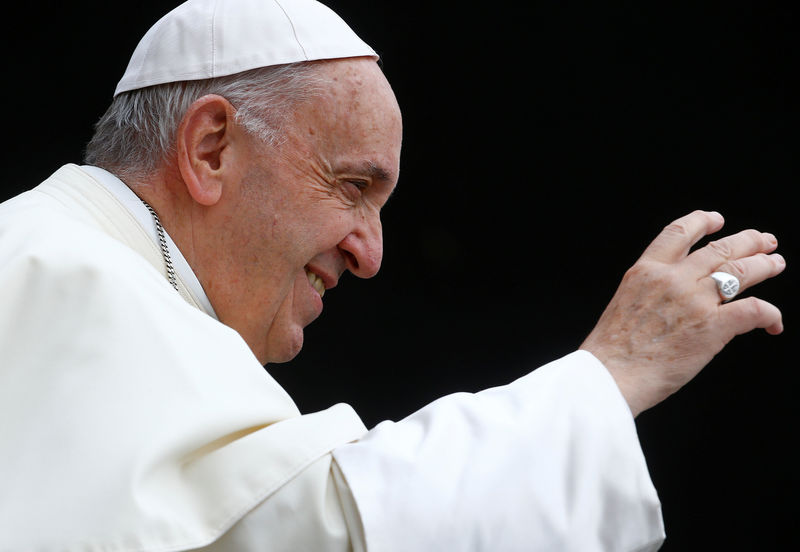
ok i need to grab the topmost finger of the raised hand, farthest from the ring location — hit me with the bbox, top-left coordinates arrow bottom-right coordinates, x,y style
642,211 -> 727,263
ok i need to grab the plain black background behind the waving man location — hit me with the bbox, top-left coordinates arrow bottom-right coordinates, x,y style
2,0 -> 800,551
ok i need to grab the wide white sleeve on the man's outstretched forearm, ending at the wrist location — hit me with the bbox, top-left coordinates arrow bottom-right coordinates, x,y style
333,351 -> 664,552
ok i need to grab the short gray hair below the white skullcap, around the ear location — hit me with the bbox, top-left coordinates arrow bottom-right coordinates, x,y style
84,62 -> 326,180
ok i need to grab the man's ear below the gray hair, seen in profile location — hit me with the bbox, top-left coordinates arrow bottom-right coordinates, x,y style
175,94 -> 236,206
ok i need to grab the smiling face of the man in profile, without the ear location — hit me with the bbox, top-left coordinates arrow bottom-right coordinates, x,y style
204,58 -> 402,363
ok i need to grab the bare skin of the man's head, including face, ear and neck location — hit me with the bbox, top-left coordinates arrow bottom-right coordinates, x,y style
137,58 -> 402,364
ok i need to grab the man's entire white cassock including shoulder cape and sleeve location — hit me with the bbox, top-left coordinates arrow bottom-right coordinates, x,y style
0,165 -> 664,552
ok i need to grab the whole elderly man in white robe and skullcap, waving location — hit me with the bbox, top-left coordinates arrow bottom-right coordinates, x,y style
0,0 -> 784,551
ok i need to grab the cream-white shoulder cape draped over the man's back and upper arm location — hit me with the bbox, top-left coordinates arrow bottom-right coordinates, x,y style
0,169 -> 365,551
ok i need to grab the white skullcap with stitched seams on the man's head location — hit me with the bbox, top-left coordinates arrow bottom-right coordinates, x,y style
114,0 -> 378,96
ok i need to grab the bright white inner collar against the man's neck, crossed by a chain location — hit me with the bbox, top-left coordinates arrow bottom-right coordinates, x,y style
81,165 -> 219,320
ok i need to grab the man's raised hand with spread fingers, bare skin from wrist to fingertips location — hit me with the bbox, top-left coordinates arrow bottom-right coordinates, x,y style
581,211 -> 785,416
